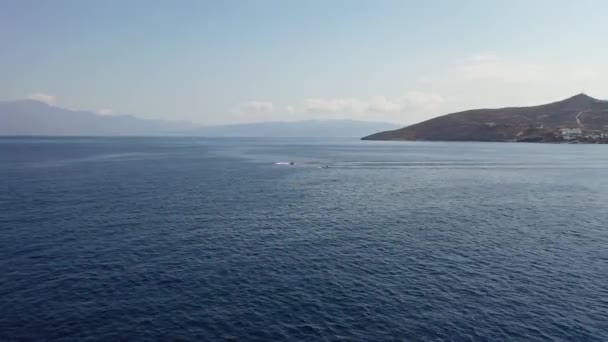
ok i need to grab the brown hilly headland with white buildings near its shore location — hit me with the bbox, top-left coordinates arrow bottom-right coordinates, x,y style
362,94 -> 608,143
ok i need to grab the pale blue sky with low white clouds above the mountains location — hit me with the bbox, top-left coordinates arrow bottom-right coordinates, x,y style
0,0 -> 608,124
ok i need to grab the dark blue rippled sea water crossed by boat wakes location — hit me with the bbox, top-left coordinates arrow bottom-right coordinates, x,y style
0,138 -> 608,341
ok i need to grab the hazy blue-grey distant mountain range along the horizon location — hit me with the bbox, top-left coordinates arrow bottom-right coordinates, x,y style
0,100 -> 399,138
